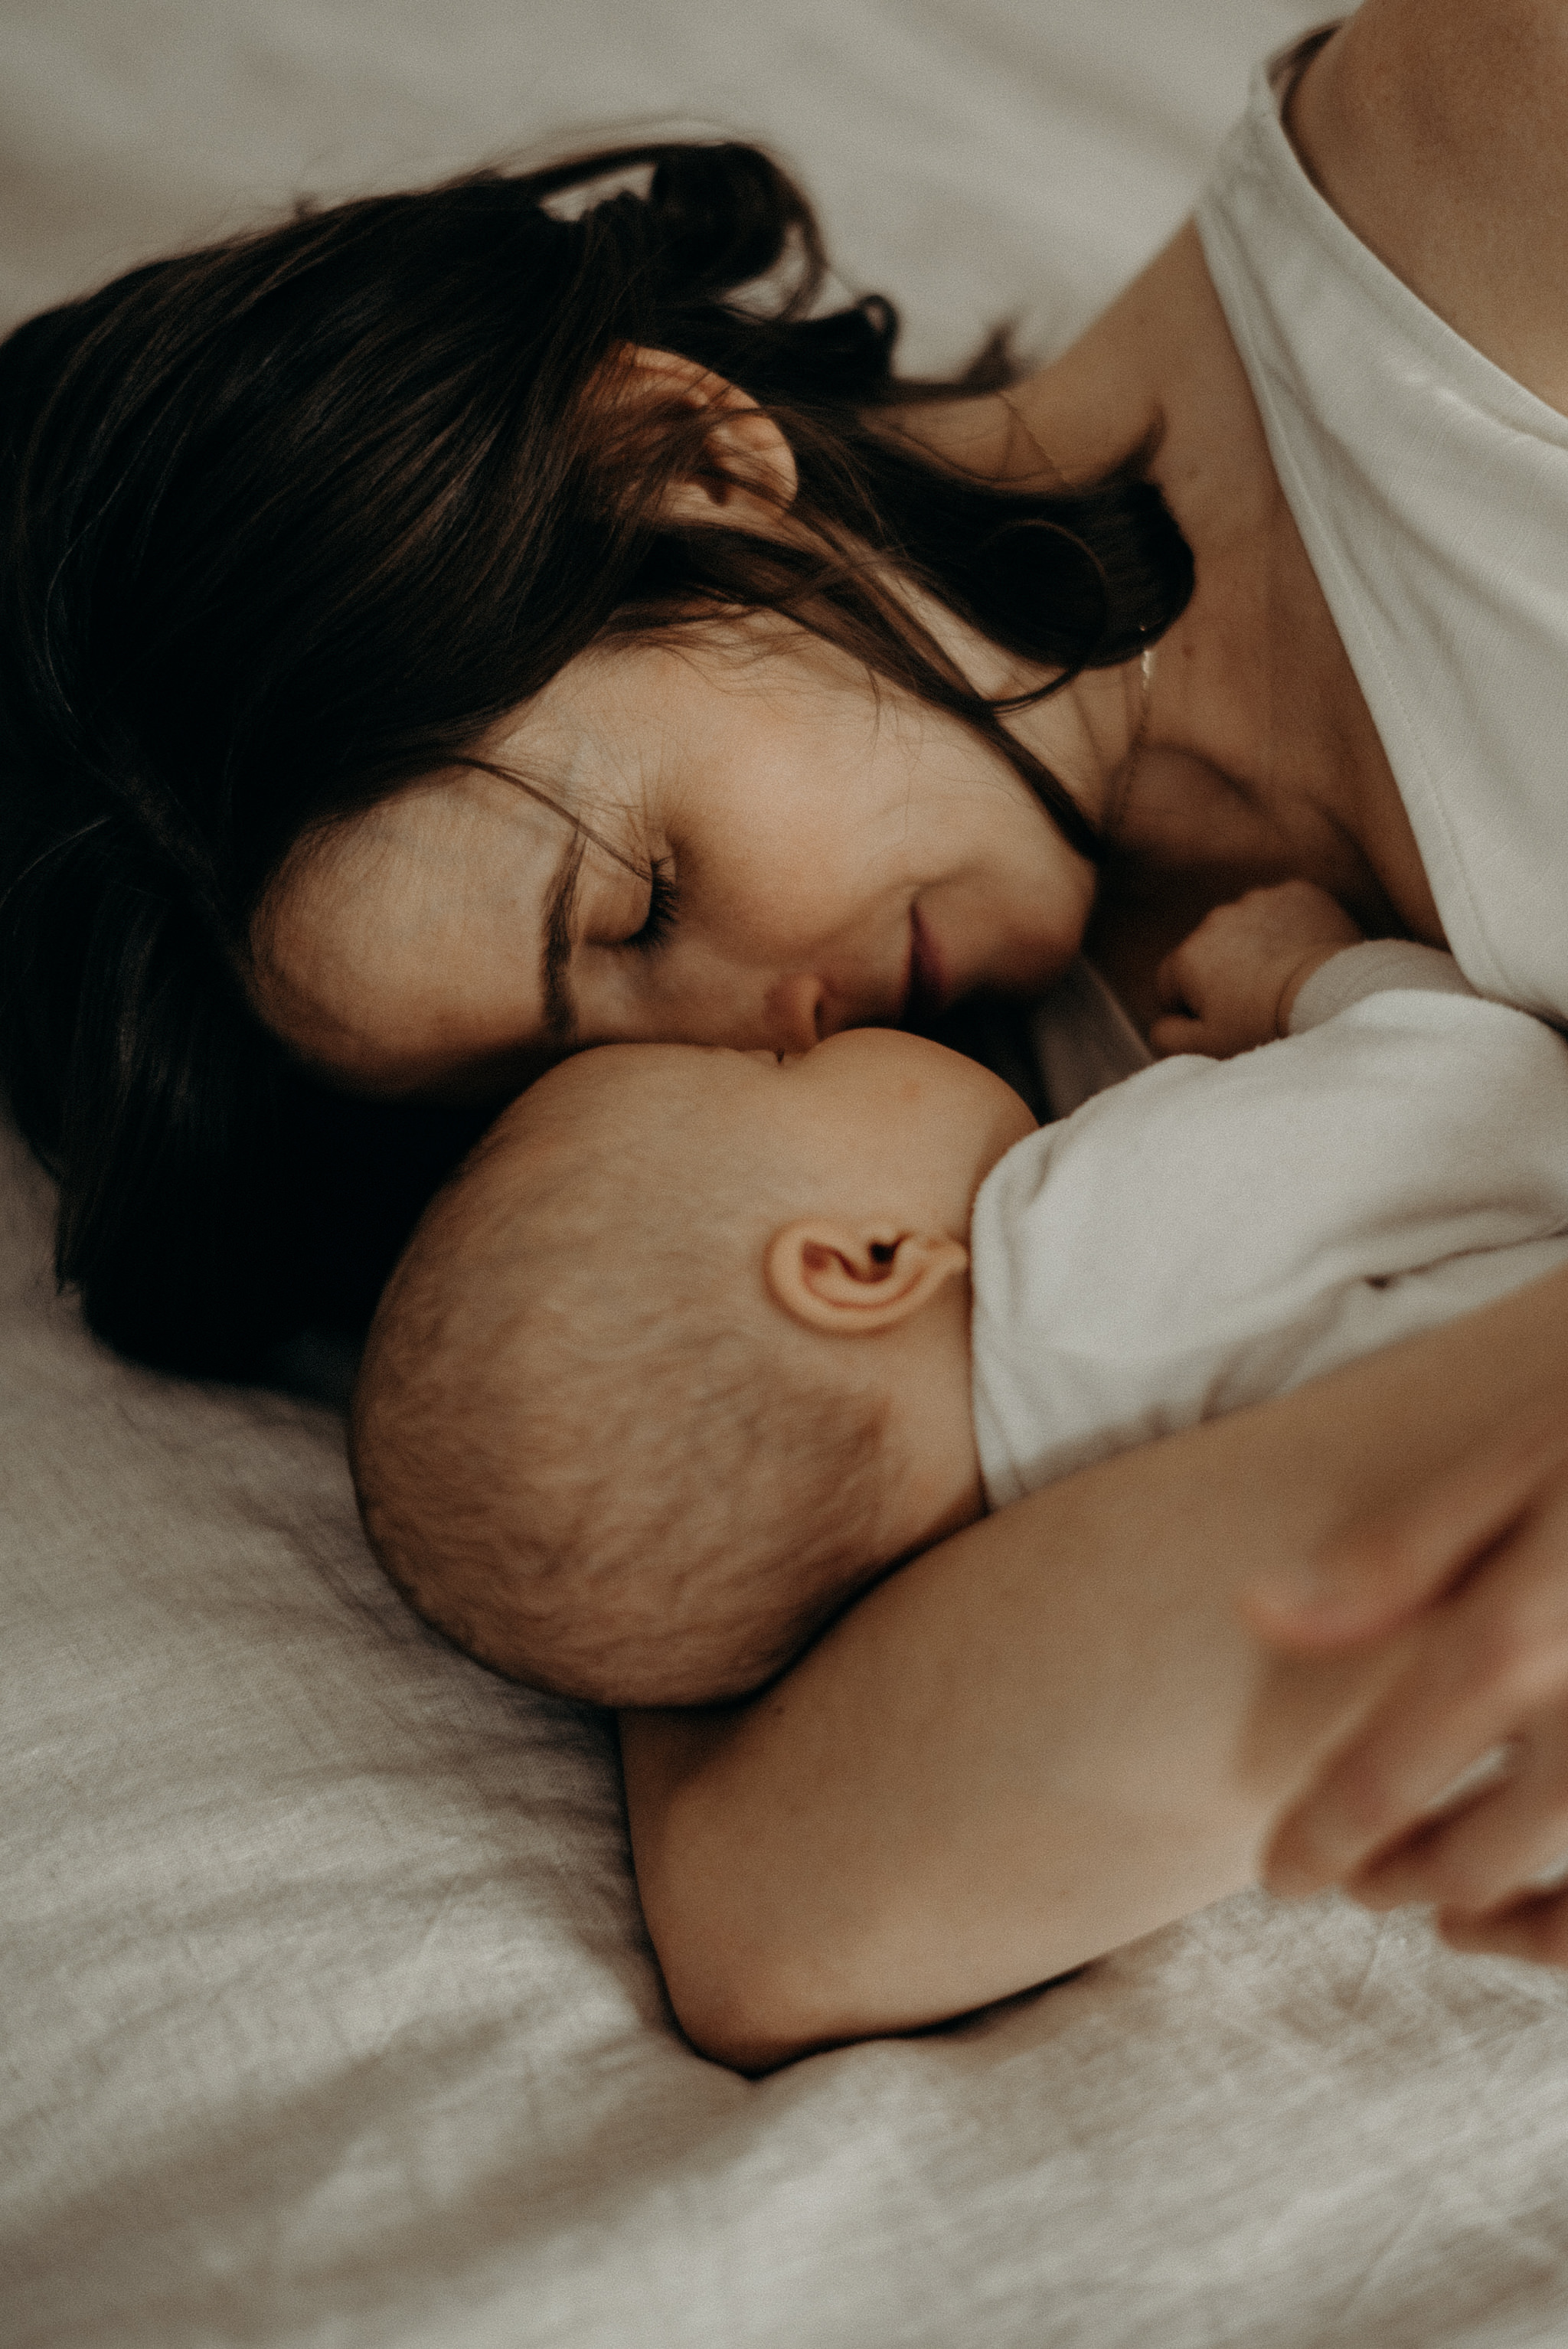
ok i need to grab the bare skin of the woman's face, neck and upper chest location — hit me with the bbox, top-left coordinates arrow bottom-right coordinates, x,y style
258,228 -> 1444,1097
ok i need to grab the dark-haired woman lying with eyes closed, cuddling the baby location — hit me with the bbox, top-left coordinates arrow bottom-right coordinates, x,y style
0,0 -> 1568,2060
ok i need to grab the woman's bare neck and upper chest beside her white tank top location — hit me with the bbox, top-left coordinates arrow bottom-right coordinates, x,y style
901,226 -> 1441,1022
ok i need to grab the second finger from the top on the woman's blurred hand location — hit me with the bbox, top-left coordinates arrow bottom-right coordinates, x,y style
1263,1498 -> 1568,1893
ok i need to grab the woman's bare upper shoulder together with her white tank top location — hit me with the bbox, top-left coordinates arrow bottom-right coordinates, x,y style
1197,0 -> 1568,1017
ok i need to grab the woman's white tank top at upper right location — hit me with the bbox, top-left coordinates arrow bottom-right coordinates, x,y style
1197,35 -> 1568,1027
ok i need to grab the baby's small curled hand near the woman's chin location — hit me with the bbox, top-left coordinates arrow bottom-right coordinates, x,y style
1148,881 -> 1364,1060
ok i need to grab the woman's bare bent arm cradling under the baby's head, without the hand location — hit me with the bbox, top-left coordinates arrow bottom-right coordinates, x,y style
622,1273 -> 1568,2070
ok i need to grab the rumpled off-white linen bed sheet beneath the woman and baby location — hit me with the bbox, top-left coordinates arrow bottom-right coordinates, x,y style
0,0 -> 1568,2349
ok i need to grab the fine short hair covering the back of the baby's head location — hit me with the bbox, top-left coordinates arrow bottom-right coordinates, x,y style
352,1045 -> 887,1705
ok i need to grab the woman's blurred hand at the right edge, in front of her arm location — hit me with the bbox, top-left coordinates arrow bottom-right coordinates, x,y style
1242,1405 -> 1568,1966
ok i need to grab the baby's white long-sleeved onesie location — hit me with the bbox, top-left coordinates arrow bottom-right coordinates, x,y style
972,942 -> 1568,1508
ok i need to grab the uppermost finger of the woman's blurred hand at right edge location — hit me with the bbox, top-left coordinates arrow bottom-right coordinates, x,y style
1240,1410 -> 1568,1654
